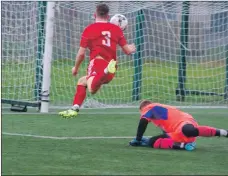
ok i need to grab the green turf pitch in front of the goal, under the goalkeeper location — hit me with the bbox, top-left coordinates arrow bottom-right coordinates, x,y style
2,109 -> 228,175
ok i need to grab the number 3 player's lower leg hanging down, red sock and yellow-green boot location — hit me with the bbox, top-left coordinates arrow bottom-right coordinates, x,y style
59,76 -> 87,118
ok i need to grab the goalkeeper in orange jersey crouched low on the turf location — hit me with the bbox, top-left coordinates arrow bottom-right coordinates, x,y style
129,100 -> 228,151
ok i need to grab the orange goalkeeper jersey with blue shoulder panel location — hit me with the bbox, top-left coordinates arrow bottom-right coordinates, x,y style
140,103 -> 195,133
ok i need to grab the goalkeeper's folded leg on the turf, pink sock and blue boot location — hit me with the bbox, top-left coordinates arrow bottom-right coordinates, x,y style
148,134 -> 195,151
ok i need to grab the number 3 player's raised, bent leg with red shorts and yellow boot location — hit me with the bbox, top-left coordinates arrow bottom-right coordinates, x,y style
87,59 -> 116,94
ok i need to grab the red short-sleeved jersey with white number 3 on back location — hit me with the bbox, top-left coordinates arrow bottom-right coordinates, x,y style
80,22 -> 127,62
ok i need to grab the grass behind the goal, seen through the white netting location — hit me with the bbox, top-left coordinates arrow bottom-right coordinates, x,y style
2,59 -> 227,105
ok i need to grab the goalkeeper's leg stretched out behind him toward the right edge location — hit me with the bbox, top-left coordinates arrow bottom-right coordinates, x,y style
182,123 -> 228,137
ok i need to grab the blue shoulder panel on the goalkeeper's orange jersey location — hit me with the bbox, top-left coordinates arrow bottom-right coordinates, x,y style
143,106 -> 168,120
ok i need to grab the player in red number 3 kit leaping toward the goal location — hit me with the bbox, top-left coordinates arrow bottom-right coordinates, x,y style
59,4 -> 136,118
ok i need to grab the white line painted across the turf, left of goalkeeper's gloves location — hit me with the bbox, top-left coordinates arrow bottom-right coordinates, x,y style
2,132 -> 134,140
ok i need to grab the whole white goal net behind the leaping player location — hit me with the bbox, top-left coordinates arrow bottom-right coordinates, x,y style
1,1 -> 228,107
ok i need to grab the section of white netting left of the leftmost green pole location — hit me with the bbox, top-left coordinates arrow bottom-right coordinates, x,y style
1,2 -> 38,101
